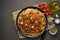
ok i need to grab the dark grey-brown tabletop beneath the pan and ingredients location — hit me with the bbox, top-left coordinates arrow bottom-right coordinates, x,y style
0,0 -> 60,40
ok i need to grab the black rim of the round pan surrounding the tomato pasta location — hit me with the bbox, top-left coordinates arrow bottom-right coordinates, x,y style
16,6 -> 47,38
